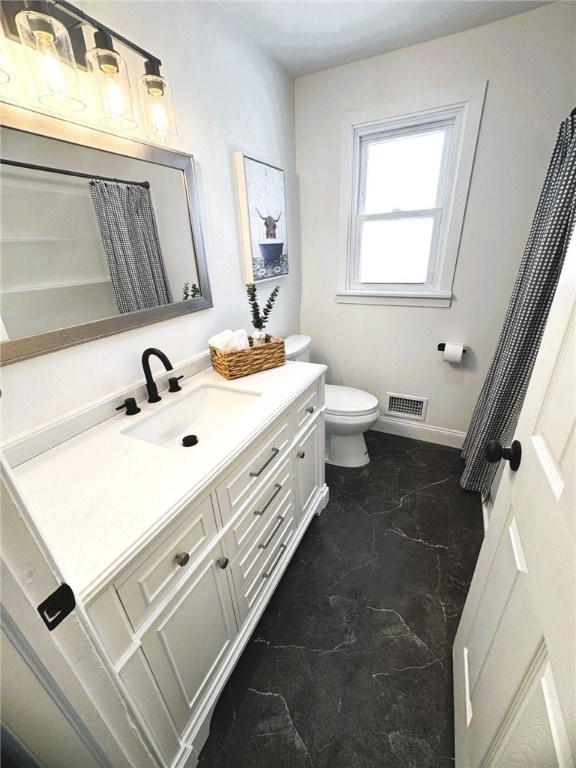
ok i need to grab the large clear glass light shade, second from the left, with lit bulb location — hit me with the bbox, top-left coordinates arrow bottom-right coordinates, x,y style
16,11 -> 86,112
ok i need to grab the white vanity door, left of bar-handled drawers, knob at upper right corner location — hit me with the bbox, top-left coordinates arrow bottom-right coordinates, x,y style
142,543 -> 237,733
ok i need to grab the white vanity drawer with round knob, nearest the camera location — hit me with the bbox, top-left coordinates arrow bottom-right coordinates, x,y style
114,496 -> 217,629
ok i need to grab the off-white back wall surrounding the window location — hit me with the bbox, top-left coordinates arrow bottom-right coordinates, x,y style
296,3 -> 576,443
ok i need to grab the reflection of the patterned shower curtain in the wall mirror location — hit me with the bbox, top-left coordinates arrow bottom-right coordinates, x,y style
90,179 -> 172,314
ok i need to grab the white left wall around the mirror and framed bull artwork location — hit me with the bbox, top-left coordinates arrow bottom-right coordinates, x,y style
0,0 -> 300,438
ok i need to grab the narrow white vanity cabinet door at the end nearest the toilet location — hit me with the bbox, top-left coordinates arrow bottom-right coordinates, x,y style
294,414 -> 324,521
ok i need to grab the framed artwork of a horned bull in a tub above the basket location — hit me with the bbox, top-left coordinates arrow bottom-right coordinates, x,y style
236,152 -> 288,283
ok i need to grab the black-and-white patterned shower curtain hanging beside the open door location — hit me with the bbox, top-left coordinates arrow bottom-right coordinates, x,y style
460,110 -> 576,499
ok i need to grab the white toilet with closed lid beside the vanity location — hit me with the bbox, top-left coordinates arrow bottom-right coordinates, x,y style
284,334 -> 380,467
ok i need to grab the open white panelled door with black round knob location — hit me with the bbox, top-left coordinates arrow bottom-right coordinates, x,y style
454,238 -> 576,768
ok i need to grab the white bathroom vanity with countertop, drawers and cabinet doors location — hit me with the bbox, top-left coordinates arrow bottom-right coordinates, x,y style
16,363 -> 328,768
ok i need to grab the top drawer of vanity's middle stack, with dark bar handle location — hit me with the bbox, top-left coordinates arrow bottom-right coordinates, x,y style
216,415 -> 292,525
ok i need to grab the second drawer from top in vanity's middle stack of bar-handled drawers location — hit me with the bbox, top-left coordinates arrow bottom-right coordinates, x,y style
226,456 -> 294,559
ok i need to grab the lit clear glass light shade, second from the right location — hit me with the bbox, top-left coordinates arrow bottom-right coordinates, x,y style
86,48 -> 137,131
